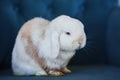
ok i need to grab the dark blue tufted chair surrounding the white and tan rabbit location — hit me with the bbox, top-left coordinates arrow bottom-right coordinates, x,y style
0,0 -> 120,80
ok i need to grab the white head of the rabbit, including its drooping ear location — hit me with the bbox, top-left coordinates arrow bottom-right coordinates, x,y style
41,15 -> 86,58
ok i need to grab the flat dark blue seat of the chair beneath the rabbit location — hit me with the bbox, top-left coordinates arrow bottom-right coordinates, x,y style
0,65 -> 120,80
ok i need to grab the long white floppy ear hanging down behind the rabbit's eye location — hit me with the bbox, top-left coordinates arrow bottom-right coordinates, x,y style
50,31 -> 60,58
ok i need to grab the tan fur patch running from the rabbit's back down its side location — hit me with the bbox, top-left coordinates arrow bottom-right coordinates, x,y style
19,18 -> 48,69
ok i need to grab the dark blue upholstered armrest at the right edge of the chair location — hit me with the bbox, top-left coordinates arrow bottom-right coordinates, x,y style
107,7 -> 120,66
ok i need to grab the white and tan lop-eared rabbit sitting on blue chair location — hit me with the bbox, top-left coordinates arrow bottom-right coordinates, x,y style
12,15 -> 86,76
